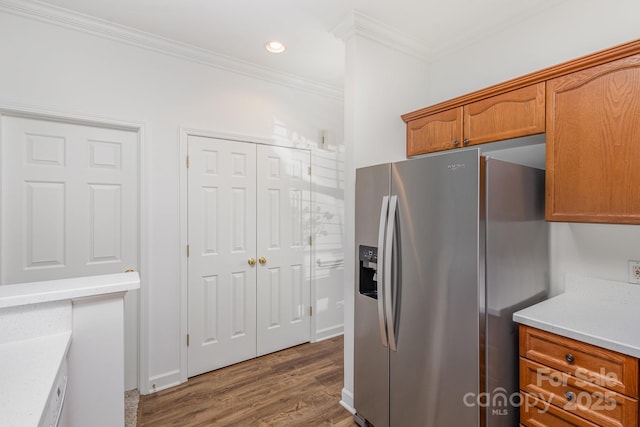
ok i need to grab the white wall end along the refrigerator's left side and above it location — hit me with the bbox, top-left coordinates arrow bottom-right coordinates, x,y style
342,27 -> 427,409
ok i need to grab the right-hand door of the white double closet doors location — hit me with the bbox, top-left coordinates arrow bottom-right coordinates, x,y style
257,145 -> 311,356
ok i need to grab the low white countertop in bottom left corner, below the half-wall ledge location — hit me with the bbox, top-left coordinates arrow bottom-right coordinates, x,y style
0,331 -> 71,427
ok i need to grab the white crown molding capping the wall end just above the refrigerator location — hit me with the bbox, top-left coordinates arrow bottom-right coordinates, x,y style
331,10 -> 433,61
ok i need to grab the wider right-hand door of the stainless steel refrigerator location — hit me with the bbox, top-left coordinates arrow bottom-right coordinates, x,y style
388,150 -> 481,427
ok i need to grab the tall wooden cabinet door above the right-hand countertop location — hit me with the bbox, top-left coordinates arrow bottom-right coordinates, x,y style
546,55 -> 640,224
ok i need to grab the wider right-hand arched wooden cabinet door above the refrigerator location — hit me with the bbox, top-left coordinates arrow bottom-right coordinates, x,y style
463,82 -> 545,145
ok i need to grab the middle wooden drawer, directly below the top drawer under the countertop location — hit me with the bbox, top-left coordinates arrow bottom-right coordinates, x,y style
520,358 -> 638,427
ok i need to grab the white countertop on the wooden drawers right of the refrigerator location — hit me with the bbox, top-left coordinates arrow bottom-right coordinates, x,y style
513,275 -> 640,358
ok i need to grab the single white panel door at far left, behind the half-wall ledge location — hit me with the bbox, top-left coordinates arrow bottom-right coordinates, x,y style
0,116 -> 138,389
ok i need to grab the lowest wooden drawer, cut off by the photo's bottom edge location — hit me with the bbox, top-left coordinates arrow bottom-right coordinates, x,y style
520,393 -> 598,427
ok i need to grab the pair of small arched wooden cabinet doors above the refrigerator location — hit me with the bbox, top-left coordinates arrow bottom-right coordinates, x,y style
407,82 -> 545,156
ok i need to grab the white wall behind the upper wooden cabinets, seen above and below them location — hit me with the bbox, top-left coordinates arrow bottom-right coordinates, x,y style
425,0 -> 640,294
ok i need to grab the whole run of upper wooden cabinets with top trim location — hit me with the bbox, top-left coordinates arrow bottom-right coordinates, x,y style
402,40 -> 640,224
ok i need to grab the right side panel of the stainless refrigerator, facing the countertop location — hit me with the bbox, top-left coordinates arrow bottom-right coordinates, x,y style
485,159 -> 549,427
